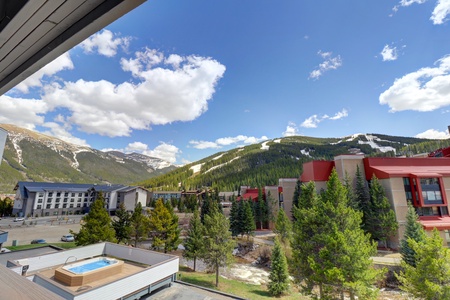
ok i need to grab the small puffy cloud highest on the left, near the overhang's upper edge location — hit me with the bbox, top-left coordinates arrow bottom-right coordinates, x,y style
80,30 -> 131,57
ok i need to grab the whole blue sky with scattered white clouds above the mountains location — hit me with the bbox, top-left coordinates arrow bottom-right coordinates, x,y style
0,0 -> 450,164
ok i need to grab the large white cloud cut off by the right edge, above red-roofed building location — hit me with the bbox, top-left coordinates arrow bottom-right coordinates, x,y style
379,55 -> 450,112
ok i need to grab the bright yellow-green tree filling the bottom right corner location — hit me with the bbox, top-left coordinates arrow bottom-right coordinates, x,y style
397,228 -> 450,300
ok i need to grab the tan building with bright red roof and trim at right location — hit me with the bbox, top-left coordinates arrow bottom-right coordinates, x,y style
301,155 -> 450,248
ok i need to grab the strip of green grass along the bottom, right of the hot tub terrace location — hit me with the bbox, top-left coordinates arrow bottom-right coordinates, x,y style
178,266 -> 310,300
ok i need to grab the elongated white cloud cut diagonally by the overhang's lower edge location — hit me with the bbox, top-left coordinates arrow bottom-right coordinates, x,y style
15,52 -> 73,93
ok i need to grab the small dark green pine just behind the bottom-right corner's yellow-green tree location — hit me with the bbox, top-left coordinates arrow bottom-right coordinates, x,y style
400,202 -> 425,267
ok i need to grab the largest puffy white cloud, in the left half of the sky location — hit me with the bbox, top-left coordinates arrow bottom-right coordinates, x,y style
35,49 -> 225,137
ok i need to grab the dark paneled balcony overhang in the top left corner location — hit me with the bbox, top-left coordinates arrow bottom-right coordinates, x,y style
0,0 -> 146,96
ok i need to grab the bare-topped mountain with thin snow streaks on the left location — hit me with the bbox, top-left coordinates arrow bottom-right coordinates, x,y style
0,124 -> 176,193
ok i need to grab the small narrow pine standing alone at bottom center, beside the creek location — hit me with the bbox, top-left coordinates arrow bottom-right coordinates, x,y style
269,238 -> 289,297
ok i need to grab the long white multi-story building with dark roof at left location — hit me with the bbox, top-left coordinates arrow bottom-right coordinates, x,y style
13,181 -> 149,216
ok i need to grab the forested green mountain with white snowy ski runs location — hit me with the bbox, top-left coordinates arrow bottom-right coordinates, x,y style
140,134 -> 450,191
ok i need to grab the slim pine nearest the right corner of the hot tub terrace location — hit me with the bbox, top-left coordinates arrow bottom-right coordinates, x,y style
183,211 -> 204,272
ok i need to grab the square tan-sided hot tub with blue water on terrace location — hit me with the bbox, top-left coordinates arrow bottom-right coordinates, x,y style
55,257 -> 123,286
